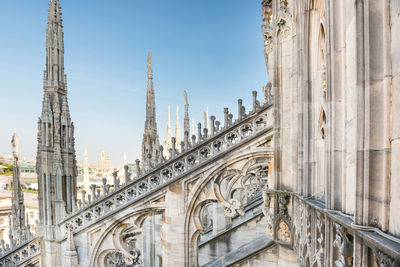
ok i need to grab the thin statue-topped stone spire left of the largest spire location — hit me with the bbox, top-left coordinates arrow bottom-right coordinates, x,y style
10,133 -> 30,240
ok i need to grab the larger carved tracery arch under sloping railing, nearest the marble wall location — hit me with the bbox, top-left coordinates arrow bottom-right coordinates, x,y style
187,153 -> 273,266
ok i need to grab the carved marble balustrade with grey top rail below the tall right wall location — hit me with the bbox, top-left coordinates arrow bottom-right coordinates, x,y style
263,189 -> 400,267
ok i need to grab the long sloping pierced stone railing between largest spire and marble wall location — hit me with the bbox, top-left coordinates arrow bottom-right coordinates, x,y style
60,95 -> 273,232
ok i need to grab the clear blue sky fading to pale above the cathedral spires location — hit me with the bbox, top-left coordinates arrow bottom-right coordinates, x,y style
0,0 -> 268,165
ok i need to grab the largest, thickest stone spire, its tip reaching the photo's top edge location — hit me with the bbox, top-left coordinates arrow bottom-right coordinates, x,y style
36,0 -> 77,248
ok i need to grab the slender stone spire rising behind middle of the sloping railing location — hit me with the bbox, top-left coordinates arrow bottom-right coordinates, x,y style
142,52 -> 160,169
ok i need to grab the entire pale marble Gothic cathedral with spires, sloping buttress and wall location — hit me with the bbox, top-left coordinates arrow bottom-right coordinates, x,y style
0,0 -> 400,267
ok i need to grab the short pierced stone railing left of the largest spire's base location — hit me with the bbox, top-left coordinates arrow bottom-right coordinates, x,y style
0,238 -> 40,267
